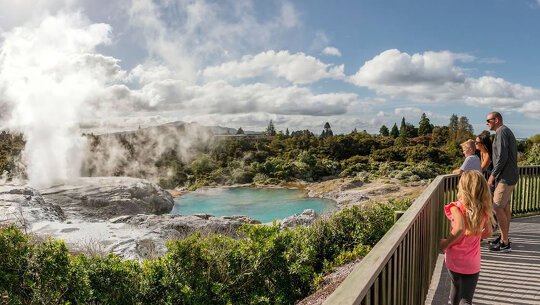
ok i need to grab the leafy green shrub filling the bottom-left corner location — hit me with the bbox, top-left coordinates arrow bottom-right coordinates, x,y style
0,226 -> 91,304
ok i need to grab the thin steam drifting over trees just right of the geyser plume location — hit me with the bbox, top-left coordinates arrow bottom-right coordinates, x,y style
82,123 -> 213,182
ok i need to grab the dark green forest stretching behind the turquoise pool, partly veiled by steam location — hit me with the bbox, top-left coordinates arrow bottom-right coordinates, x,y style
0,114 -> 540,190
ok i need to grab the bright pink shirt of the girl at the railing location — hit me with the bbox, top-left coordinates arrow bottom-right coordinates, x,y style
444,201 -> 481,274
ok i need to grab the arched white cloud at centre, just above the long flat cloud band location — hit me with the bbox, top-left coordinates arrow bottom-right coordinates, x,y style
202,50 -> 345,84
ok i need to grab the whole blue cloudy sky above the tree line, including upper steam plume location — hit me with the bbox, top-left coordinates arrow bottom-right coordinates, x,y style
0,0 -> 540,138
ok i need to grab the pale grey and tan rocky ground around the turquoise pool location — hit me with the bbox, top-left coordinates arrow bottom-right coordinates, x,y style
0,177 -> 423,259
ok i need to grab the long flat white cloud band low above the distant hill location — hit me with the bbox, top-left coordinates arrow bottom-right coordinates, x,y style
110,79 -> 358,116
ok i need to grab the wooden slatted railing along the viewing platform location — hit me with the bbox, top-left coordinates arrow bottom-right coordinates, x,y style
324,166 -> 540,305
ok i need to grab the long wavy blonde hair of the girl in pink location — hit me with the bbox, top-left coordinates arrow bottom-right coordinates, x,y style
458,170 -> 493,235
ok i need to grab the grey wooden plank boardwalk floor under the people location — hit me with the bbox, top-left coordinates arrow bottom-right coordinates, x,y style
426,216 -> 540,305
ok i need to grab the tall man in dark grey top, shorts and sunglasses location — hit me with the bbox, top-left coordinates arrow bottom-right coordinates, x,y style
486,112 -> 519,252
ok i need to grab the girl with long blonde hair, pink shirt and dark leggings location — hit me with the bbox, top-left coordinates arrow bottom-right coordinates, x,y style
441,170 -> 493,305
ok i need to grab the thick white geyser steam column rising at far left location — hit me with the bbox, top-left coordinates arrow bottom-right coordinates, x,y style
0,14 -> 111,188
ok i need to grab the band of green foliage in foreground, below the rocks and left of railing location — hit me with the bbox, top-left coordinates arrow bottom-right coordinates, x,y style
0,201 -> 410,304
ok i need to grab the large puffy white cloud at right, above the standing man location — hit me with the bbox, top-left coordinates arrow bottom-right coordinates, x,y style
349,49 -> 540,113
